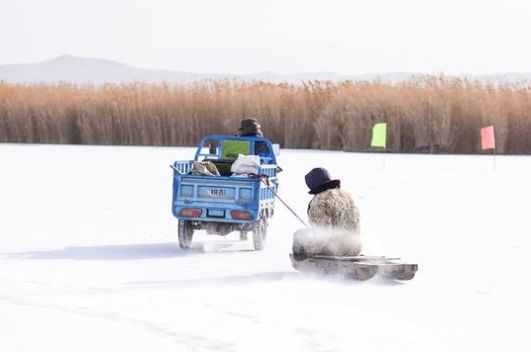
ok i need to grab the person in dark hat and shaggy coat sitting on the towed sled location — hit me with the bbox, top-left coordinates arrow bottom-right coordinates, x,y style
293,167 -> 361,259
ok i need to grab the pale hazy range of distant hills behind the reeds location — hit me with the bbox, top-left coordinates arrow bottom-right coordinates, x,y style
0,55 -> 531,84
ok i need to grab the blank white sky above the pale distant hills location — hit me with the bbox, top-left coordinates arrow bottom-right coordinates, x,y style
0,0 -> 531,74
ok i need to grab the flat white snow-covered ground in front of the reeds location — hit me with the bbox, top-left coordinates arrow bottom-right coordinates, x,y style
0,144 -> 531,352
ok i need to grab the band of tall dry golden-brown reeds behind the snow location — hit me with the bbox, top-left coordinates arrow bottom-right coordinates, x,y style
0,77 -> 531,154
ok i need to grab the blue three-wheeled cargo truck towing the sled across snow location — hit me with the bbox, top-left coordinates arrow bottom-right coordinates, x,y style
172,135 -> 279,250
